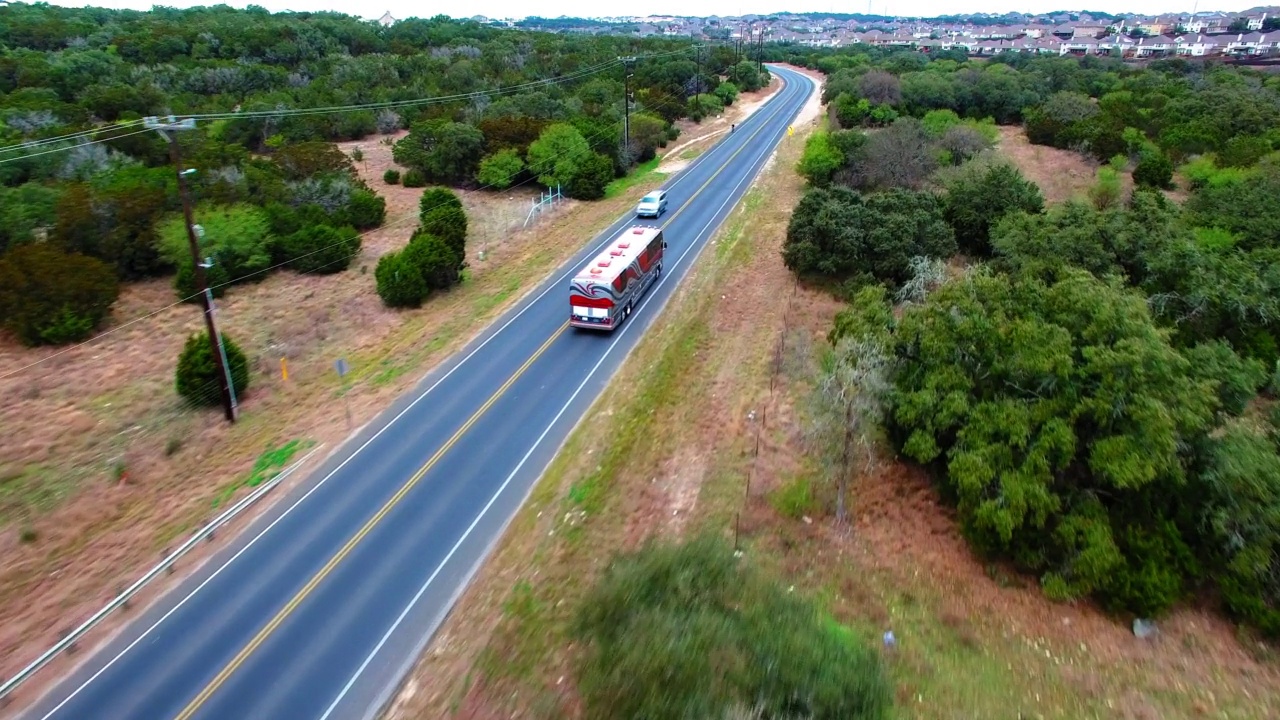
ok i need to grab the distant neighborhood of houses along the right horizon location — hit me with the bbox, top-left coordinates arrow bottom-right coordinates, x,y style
379,6 -> 1280,59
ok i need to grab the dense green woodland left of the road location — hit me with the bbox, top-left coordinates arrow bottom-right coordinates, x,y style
0,4 -> 767,351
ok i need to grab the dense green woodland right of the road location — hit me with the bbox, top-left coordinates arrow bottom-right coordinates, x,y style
783,47 -> 1280,635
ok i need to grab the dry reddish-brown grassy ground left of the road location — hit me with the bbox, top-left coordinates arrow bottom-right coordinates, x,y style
0,79 -> 772,708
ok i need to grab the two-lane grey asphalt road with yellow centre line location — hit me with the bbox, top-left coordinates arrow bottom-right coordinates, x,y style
27,68 -> 814,720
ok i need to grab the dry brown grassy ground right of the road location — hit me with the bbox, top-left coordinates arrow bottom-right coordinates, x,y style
389,85 -> 1280,720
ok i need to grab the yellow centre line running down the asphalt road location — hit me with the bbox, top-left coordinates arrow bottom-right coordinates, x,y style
177,68 -> 803,720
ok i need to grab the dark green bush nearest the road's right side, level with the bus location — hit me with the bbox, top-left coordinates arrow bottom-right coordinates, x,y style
782,186 -> 956,286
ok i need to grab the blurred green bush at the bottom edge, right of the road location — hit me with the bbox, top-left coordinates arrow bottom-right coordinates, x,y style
571,536 -> 892,720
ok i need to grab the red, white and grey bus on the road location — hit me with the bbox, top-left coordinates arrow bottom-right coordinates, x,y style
568,225 -> 667,331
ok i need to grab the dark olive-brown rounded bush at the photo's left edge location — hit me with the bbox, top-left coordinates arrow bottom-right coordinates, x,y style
0,243 -> 120,346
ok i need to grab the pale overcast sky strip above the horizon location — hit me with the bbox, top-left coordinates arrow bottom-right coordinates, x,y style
35,0 -> 1266,19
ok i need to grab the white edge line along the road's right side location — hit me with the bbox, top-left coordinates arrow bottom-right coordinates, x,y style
320,67 -> 813,720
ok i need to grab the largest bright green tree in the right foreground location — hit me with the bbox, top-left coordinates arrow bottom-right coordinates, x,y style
860,270 -> 1217,615
